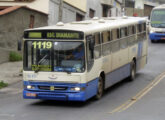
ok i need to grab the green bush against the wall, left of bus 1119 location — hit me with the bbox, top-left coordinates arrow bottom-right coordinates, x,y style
9,51 -> 22,62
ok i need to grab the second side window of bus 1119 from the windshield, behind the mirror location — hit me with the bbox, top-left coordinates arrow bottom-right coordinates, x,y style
94,33 -> 101,59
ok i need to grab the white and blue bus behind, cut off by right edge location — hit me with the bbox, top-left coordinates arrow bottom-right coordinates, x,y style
149,4 -> 165,43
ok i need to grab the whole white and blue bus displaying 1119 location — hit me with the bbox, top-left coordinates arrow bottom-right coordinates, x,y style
23,17 -> 148,101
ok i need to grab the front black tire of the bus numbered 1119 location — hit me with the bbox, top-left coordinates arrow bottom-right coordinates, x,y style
95,77 -> 104,100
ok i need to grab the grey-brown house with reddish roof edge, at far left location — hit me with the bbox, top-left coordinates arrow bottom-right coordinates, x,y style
0,6 -> 48,63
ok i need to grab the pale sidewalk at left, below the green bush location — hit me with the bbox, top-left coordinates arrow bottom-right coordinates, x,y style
0,61 -> 22,85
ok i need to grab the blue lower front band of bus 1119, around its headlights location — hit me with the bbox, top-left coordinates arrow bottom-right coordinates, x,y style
23,78 -> 98,101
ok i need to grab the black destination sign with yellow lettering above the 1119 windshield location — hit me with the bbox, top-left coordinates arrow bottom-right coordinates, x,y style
24,31 -> 84,40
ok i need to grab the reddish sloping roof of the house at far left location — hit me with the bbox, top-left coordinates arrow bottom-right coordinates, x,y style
0,5 -> 48,16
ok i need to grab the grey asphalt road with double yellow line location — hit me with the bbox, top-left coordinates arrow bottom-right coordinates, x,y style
0,42 -> 165,120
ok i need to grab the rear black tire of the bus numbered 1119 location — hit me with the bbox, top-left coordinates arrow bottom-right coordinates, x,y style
128,61 -> 136,81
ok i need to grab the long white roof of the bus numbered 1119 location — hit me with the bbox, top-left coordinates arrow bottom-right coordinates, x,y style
25,17 -> 146,33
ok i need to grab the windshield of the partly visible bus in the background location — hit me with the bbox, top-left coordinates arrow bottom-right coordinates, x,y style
151,9 -> 165,28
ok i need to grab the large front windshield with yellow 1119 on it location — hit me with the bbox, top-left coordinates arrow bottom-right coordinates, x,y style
24,41 -> 85,73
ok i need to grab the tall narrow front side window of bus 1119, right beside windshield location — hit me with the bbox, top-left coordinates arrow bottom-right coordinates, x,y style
86,35 -> 94,71
